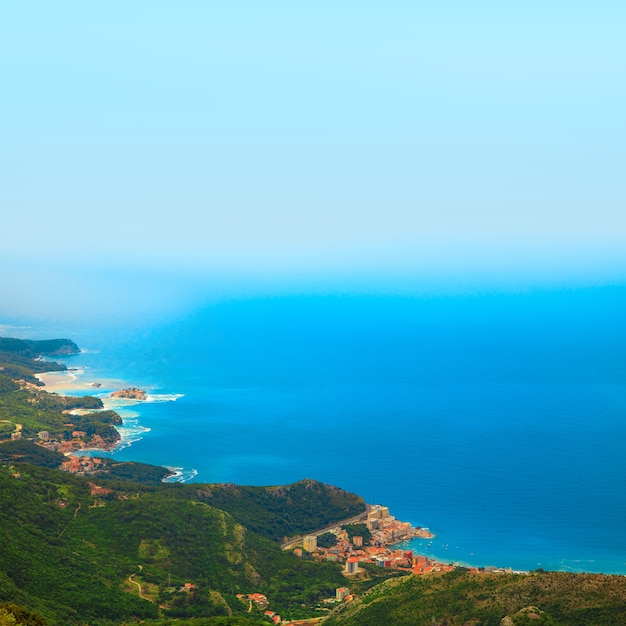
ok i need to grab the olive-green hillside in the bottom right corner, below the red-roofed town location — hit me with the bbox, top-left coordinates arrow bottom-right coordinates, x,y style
324,570 -> 626,626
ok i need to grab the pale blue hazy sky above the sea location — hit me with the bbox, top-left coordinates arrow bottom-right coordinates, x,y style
0,0 -> 626,314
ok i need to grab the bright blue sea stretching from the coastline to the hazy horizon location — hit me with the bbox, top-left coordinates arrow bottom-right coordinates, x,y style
3,285 -> 626,574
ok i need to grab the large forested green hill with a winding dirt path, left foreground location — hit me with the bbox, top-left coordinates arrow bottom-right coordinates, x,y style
0,464 -> 354,626
